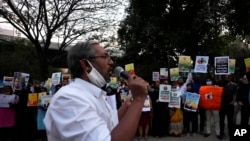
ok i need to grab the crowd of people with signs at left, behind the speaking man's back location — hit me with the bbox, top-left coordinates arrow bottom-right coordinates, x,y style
0,78 -> 68,141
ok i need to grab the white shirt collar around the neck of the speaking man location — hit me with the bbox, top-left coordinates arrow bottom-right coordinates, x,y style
74,78 -> 107,97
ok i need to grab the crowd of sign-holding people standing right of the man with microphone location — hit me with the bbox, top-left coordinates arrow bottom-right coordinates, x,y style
107,72 -> 250,140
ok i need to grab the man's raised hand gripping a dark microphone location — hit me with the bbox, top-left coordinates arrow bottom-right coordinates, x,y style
114,66 -> 149,101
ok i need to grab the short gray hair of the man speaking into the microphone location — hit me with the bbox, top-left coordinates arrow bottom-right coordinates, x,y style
67,41 -> 99,78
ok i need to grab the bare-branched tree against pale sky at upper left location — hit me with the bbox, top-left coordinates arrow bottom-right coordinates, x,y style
0,0 -> 122,80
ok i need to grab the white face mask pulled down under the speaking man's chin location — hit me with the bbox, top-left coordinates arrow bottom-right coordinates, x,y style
86,61 -> 107,88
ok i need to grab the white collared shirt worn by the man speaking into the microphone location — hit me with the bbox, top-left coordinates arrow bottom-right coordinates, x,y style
44,78 -> 118,141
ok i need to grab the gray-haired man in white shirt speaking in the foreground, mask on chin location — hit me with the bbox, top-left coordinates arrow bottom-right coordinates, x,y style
44,41 -> 148,141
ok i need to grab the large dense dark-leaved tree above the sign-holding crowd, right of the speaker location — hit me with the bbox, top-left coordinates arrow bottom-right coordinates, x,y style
118,0 -> 226,79
